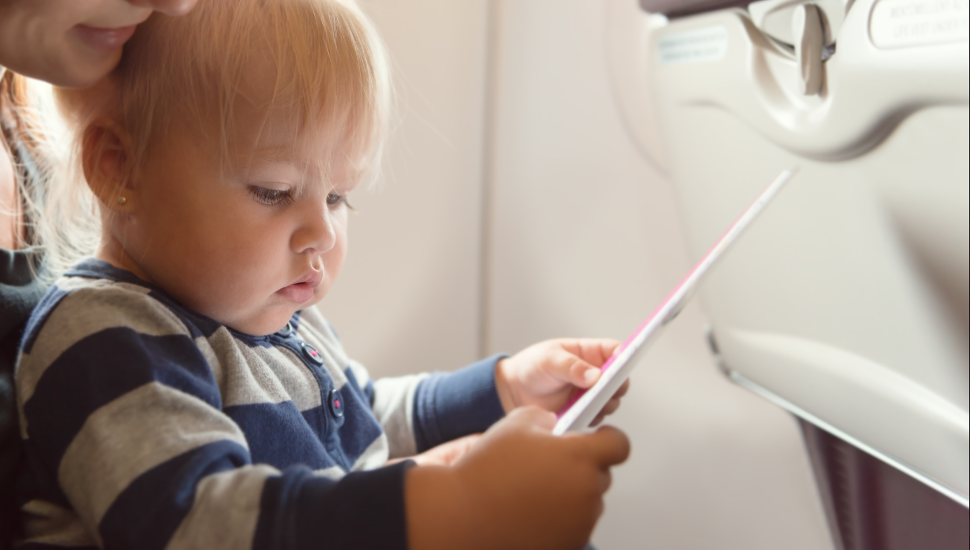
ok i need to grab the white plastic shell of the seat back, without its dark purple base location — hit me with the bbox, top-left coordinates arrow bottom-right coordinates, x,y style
648,0 -> 970,501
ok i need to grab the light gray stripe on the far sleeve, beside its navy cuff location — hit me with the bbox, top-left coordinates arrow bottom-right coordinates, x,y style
373,374 -> 429,458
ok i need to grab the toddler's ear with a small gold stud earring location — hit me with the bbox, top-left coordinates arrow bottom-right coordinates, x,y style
81,119 -> 134,213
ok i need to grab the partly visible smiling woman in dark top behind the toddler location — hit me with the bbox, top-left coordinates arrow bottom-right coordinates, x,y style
0,0 -> 196,550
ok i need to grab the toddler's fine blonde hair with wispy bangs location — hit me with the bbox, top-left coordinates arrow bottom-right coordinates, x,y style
41,0 -> 391,274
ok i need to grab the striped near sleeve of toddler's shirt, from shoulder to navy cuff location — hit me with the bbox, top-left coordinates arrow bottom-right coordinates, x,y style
17,284 -> 410,549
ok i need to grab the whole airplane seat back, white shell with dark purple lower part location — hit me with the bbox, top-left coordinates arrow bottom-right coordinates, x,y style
614,0 -> 970,550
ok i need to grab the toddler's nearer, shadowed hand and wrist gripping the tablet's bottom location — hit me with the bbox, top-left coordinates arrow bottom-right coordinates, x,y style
405,407 -> 630,550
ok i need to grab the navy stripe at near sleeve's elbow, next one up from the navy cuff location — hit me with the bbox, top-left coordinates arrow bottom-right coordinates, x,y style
98,441 -> 250,550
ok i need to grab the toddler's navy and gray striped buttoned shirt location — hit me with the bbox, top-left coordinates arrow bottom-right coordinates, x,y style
16,260 -> 503,550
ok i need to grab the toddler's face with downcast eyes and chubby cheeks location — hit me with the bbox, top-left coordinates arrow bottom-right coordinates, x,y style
111,105 -> 355,335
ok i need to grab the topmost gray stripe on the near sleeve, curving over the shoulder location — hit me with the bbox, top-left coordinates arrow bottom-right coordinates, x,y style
17,277 -> 188,439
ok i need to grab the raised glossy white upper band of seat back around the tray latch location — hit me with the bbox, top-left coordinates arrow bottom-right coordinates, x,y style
648,0 -> 970,160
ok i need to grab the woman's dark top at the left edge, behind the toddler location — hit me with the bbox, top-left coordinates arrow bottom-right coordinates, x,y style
0,248 -> 45,548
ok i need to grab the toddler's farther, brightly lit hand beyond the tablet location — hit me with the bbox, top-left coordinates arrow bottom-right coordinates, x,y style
495,338 -> 630,426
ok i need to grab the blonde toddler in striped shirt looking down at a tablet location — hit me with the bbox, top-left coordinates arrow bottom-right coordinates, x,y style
16,0 -> 627,550
